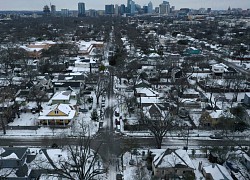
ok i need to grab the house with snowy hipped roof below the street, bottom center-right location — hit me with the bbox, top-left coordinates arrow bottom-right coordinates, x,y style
152,149 -> 195,179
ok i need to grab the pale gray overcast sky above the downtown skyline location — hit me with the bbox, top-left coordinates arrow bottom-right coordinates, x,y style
0,0 -> 250,11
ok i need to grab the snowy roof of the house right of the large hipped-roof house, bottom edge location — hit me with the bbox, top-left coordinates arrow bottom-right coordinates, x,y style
202,163 -> 233,180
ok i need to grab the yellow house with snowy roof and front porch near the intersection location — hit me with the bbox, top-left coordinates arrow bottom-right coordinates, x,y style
38,104 -> 77,127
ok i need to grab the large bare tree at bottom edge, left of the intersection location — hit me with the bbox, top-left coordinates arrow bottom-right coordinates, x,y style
34,137 -> 105,180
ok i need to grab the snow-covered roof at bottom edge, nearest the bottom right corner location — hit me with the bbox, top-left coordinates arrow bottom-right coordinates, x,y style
203,164 -> 233,180
